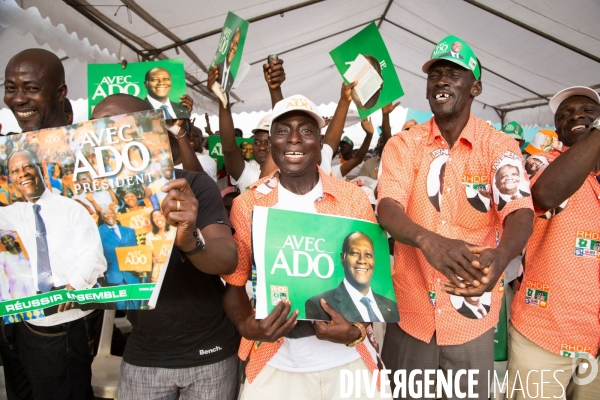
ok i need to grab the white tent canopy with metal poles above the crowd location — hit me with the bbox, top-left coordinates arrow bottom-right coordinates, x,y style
0,0 -> 600,129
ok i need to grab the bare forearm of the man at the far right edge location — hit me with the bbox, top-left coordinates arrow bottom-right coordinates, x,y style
531,129 -> 600,210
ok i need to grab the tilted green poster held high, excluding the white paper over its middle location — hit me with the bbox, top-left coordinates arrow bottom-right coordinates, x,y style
329,22 -> 404,119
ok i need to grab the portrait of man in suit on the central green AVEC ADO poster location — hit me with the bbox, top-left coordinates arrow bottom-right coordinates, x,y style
305,232 -> 400,322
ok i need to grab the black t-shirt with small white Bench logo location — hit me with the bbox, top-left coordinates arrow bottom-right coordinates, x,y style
123,170 -> 240,368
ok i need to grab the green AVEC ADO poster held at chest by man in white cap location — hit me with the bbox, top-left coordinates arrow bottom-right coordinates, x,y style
252,207 -> 399,322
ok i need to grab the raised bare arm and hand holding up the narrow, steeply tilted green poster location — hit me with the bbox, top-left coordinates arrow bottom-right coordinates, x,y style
207,66 -> 246,181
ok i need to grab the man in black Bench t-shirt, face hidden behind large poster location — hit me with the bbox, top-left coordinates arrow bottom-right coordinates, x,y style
92,94 -> 240,400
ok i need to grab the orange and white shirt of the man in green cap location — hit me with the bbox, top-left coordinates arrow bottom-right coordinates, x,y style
379,115 -> 533,346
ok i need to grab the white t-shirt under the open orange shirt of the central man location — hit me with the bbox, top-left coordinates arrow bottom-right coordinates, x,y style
267,180 -> 375,372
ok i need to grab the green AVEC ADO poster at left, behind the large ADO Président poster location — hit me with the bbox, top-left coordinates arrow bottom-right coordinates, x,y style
88,58 -> 190,119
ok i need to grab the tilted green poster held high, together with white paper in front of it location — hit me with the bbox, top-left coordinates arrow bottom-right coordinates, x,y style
329,22 -> 404,119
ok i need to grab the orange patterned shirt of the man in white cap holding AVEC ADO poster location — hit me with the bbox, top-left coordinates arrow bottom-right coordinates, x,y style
222,168 -> 377,383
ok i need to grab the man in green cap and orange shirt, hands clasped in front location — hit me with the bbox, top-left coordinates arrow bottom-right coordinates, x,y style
378,36 -> 533,399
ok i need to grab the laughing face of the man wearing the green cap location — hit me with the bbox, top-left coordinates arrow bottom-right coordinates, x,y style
426,60 -> 482,118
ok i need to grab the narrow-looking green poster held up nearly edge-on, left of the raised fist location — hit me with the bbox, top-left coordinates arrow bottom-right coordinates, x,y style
210,12 -> 250,93
